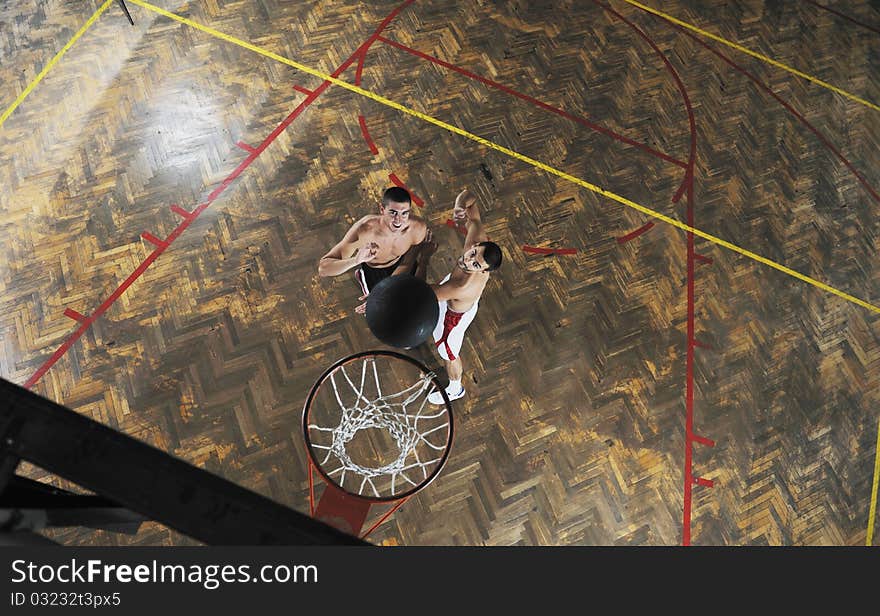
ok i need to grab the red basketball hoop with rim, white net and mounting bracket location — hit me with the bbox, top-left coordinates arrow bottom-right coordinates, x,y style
303,351 -> 453,537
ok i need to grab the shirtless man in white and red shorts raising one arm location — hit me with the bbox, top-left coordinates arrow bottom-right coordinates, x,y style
417,189 -> 501,404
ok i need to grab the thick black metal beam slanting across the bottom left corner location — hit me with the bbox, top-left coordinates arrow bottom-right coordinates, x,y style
0,379 -> 369,545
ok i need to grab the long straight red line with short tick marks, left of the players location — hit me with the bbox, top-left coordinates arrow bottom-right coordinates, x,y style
24,0 -> 414,389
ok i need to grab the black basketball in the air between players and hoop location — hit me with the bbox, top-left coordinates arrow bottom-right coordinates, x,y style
367,274 -> 440,349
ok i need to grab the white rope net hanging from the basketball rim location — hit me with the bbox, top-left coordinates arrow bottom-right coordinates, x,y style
309,357 -> 450,497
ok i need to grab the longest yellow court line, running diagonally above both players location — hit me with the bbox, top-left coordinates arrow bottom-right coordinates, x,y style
129,0 -> 880,314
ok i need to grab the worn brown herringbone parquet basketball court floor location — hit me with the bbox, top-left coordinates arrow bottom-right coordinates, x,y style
0,0 -> 880,546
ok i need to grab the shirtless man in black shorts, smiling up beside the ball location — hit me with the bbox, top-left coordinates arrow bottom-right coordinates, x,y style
318,186 -> 430,314
